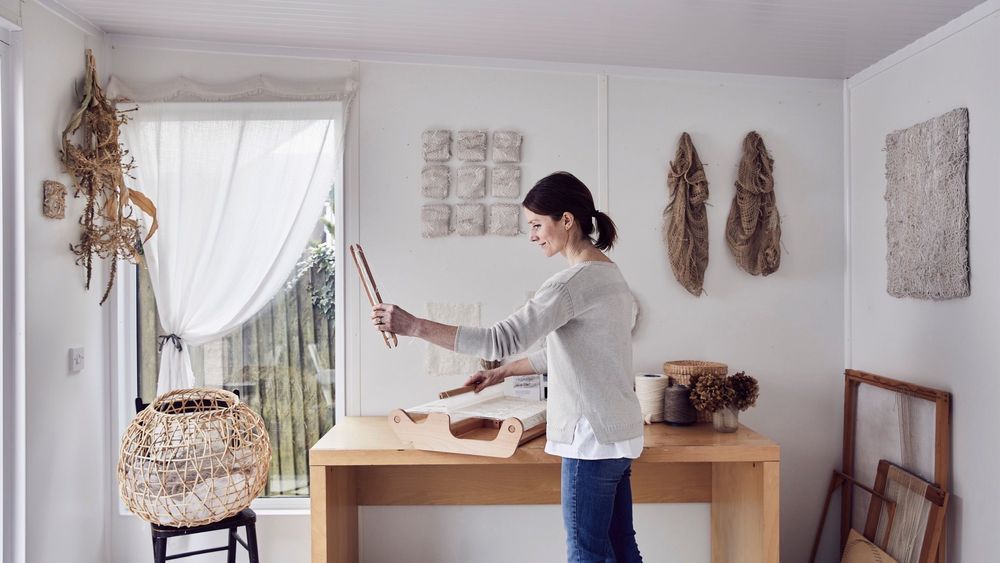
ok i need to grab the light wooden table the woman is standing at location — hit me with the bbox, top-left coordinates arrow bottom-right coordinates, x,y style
309,417 -> 781,563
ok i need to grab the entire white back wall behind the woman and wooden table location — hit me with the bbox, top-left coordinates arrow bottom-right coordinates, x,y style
101,45 -> 843,563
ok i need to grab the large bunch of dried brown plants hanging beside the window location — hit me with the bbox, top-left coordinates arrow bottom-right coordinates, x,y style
60,49 -> 157,305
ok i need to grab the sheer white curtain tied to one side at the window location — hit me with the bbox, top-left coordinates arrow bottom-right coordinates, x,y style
115,78 -> 354,394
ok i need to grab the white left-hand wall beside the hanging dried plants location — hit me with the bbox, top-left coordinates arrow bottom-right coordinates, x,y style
22,2 -> 111,563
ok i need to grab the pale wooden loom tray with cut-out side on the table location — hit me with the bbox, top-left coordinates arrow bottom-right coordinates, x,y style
388,394 -> 545,457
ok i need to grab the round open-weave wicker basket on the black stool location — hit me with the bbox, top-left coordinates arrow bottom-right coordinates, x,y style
118,388 -> 271,527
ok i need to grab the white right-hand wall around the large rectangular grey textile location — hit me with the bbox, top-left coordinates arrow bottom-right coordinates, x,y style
848,1 -> 1000,563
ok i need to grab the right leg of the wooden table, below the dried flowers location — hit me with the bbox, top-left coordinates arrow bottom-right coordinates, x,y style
712,461 -> 779,563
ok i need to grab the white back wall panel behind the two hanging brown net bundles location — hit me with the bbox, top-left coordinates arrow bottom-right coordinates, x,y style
608,76 -> 843,561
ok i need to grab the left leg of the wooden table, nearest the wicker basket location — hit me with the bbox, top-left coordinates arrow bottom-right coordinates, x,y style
309,465 -> 358,563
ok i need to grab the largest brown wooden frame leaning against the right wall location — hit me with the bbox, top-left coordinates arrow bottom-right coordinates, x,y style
840,369 -> 951,563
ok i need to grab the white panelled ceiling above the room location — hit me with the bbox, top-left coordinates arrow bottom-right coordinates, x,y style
50,0 -> 982,78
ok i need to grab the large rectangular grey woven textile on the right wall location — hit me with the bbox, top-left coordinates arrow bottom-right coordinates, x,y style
885,108 -> 969,300
